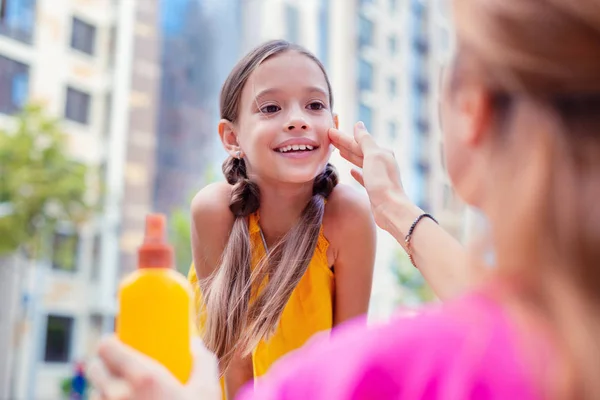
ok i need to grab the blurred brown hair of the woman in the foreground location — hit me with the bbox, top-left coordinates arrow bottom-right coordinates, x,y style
452,0 -> 600,399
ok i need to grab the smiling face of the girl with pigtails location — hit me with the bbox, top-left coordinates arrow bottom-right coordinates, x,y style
221,51 -> 337,183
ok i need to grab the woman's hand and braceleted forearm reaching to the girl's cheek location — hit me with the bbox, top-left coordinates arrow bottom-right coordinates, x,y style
329,122 -> 469,300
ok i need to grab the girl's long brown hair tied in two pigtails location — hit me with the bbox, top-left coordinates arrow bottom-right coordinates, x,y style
202,40 -> 338,372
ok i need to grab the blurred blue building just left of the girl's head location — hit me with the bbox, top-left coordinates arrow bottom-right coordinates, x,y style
154,0 -> 243,214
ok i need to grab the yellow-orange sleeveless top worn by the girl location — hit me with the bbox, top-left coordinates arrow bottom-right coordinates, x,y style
188,212 -> 335,392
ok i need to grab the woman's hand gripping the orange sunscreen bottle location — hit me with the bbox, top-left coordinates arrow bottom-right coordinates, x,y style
89,336 -> 221,400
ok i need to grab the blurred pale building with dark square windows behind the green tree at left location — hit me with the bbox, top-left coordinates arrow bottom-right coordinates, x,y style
0,0 -> 160,399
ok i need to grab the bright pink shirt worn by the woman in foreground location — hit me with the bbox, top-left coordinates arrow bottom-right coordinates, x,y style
237,294 -> 548,400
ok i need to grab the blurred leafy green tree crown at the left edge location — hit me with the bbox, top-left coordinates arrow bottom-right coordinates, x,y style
0,105 -> 93,259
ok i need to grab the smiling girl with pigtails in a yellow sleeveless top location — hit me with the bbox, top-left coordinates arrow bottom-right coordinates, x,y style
189,41 -> 376,398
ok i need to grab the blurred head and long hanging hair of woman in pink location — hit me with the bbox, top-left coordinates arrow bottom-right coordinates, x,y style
442,0 -> 600,398
